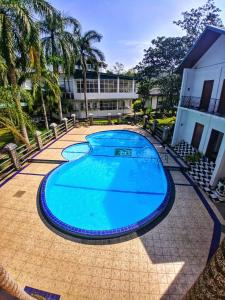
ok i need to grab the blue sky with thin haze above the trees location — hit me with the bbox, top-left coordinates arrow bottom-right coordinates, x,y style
50,0 -> 225,69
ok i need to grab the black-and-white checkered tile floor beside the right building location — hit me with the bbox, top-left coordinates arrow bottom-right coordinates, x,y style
173,141 -> 221,202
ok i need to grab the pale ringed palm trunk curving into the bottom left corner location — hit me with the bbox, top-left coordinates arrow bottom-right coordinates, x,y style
0,265 -> 35,300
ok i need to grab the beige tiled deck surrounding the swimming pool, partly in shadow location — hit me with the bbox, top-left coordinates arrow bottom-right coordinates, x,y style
0,125 -> 221,300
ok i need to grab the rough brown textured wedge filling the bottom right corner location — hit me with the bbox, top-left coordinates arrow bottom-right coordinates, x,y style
183,238 -> 225,300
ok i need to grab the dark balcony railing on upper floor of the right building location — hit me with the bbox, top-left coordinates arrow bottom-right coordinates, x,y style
180,96 -> 225,117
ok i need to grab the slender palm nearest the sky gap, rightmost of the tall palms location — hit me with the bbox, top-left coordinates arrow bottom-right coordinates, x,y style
74,30 -> 105,118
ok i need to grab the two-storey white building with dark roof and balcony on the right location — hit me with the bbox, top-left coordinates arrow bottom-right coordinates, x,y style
172,26 -> 225,186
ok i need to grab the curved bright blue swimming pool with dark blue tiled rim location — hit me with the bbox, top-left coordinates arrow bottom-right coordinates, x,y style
40,130 -> 170,238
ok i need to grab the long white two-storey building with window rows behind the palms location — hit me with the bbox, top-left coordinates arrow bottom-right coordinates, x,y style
60,69 -> 138,118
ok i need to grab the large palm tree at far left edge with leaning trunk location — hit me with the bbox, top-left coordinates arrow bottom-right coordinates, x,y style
0,0 -> 55,144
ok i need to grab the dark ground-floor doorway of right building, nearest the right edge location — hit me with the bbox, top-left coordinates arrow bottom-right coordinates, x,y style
206,129 -> 224,161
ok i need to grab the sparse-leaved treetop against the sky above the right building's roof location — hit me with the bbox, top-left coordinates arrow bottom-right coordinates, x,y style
173,0 -> 223,48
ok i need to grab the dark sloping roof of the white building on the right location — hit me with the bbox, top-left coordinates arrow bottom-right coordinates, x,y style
177,25 -> 225,72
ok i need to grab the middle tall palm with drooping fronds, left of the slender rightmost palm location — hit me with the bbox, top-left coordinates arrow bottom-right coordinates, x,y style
39,14 -> 79,120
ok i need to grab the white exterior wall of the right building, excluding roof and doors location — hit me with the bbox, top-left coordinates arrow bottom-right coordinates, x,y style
172,36 -> 225,186
